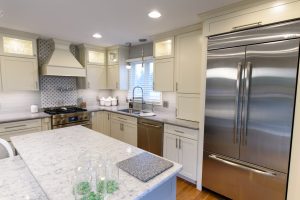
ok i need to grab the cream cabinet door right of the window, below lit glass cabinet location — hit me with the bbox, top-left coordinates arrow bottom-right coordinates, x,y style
153,58 -> 174,92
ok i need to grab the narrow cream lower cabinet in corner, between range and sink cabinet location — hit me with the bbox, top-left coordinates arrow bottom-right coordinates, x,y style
92,111 -> 110,136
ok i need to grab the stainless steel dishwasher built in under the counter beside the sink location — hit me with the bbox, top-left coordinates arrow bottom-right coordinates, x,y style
138,118 -> 164,156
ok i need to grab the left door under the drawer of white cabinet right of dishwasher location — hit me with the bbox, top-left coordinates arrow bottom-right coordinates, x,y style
164,133 -> 179,162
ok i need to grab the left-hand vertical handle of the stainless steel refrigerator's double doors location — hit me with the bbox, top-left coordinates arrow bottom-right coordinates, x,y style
233,62 -> 242,144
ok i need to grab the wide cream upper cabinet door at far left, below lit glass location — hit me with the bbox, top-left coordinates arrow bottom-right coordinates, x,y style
0,56 -> 38,91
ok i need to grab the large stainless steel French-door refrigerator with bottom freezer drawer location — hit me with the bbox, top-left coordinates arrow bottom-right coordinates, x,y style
203,21 -> 300,200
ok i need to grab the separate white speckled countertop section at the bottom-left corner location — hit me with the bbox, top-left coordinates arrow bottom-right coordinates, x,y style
0,156 -> 47,200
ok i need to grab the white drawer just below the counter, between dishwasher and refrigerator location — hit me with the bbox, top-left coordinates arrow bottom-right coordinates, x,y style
164,124 -> 198,140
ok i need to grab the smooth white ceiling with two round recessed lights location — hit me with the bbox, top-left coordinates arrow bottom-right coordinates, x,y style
0,0 -> 240,46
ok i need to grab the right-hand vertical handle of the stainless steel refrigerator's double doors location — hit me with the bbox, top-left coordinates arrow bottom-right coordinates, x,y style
242,62 -> 252,145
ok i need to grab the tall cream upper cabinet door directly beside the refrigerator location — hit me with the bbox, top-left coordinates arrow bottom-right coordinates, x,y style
175,31 -> 201,93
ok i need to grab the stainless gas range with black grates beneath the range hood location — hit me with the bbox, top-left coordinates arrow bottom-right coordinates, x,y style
44,107 -> 92,129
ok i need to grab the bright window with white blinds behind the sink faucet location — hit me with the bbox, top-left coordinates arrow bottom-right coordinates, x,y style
128,61 -> 161,103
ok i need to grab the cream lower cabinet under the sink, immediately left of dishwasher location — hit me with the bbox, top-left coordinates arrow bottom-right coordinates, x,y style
110,113 -> 137,146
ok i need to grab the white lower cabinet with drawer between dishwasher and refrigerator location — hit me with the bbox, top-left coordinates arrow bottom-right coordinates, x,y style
164,125 -> 198,182
